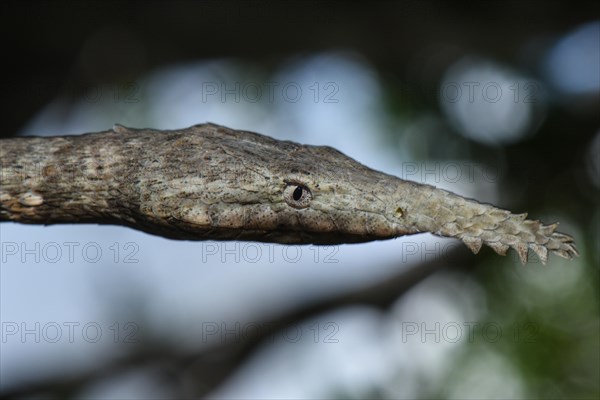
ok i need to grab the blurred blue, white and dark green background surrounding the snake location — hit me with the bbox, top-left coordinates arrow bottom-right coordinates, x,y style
0,0 -> 600,399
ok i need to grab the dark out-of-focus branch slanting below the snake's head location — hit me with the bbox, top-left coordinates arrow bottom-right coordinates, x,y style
2,248 -> 470,398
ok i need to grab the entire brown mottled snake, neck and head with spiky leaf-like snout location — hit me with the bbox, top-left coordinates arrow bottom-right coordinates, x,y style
0,124 -> 577,262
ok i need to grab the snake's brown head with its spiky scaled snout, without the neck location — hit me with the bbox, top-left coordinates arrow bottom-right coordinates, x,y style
136,125 -> 577,263
